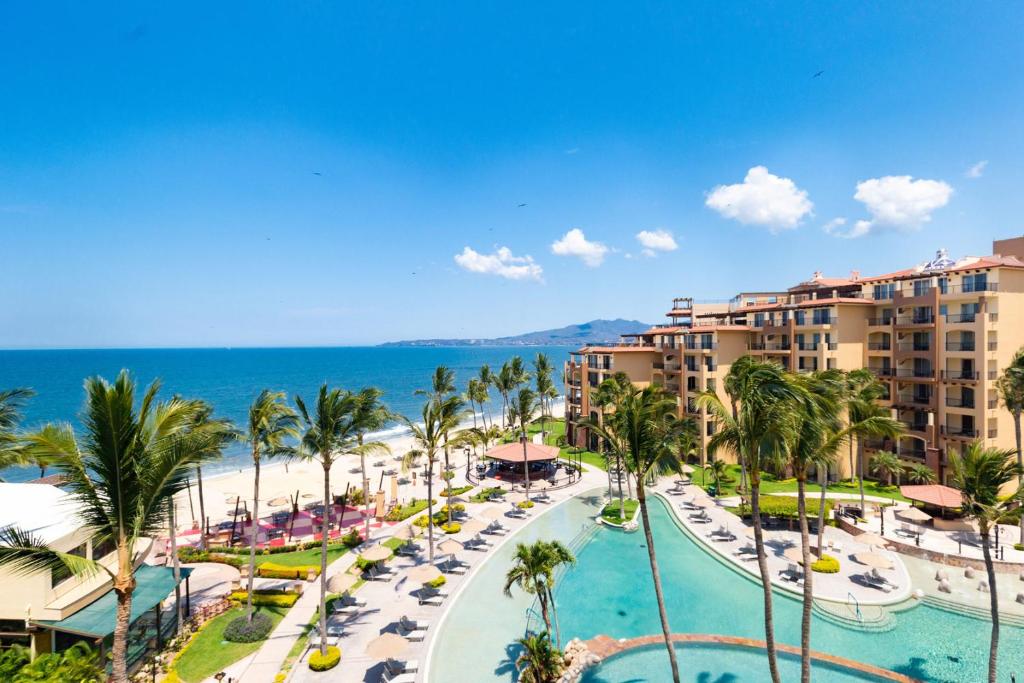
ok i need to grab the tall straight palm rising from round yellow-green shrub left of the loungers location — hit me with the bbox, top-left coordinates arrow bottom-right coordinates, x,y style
295,383 -> 387,656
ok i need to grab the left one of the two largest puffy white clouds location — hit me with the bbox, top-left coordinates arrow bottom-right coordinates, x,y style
705,166 -> 814,232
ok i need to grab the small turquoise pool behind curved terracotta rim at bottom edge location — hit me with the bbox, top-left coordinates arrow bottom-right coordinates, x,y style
582,644 -> 897,683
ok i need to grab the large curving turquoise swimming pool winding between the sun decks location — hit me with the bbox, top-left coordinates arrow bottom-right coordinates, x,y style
430,492 -> 1024,683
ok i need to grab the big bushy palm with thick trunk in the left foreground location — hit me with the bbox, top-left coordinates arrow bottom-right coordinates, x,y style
0,372 -> 233,683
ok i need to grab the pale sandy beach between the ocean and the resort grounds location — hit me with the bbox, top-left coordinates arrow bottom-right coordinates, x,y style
175,400 -> 564,531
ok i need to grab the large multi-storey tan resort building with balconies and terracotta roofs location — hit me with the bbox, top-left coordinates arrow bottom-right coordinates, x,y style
565,238 -> 1024,482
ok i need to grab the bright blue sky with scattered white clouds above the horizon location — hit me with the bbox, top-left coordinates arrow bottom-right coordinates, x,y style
0,2 -> 1024,348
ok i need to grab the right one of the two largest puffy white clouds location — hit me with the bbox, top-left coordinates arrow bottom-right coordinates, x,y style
853,175 -> 953,232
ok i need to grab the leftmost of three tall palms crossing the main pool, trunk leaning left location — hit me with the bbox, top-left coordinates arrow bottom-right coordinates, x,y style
585,386 -> 683,683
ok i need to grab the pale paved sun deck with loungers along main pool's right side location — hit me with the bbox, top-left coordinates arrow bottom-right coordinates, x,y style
655,479 -> 911,605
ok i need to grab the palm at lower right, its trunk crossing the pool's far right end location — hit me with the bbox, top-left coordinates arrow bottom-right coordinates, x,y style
949,441 -> 1022,683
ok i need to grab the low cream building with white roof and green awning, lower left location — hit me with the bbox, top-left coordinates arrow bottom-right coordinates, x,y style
0,483 -> 188,663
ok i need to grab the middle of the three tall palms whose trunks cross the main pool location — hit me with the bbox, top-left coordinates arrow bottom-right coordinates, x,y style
696,355 -> 799,683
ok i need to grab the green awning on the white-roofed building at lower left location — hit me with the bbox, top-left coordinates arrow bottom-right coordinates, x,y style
33,564 -> 191,638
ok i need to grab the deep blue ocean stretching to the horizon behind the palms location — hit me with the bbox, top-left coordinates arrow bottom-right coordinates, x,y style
0,346 -> 569,481
